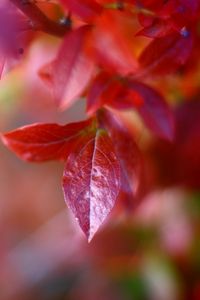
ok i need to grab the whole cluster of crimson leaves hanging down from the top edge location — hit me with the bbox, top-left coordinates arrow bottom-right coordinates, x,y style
0,0 -> 200,241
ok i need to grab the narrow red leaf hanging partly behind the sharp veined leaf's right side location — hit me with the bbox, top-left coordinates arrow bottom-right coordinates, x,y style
98,110 -> 143,208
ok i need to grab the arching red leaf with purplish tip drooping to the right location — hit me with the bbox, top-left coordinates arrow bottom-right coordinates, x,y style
107,80 -> 174,140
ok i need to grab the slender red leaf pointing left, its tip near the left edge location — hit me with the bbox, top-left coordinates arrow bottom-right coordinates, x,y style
1,119 -> 92,162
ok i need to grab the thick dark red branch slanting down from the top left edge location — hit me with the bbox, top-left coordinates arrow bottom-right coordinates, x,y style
10,0 -> 71,37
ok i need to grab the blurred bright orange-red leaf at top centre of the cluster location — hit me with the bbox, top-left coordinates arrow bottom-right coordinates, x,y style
90,11 -> 138,75
